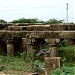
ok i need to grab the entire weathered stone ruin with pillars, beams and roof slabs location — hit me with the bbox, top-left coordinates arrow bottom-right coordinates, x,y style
0,24 -> 75,75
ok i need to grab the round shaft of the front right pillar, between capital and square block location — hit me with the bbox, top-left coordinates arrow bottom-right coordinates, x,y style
49,44 -> 58,57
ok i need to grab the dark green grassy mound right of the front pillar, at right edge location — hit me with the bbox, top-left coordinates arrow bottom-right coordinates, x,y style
58,45 -> 75,62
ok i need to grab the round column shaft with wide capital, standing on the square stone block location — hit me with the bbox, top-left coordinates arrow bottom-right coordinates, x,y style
45,38 -> 60,57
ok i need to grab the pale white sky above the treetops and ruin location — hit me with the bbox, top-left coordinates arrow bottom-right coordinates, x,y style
0,0 -> 75,22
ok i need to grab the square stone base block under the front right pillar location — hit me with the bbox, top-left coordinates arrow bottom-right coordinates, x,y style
45,57 -> 61,75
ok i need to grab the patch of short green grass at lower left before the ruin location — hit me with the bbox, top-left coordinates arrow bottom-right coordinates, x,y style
0,56 -> 32,75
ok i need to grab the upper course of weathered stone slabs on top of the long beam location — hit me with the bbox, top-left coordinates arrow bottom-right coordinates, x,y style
7,24 -> 75,31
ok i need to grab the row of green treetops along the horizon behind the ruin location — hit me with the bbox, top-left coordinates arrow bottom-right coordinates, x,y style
0,18 -> 73,24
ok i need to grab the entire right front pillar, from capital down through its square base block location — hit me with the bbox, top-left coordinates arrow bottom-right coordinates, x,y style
45,38 -> 60,75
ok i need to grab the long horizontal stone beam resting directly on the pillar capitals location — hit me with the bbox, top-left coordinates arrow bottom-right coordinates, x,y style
0,30 -> 75,40
